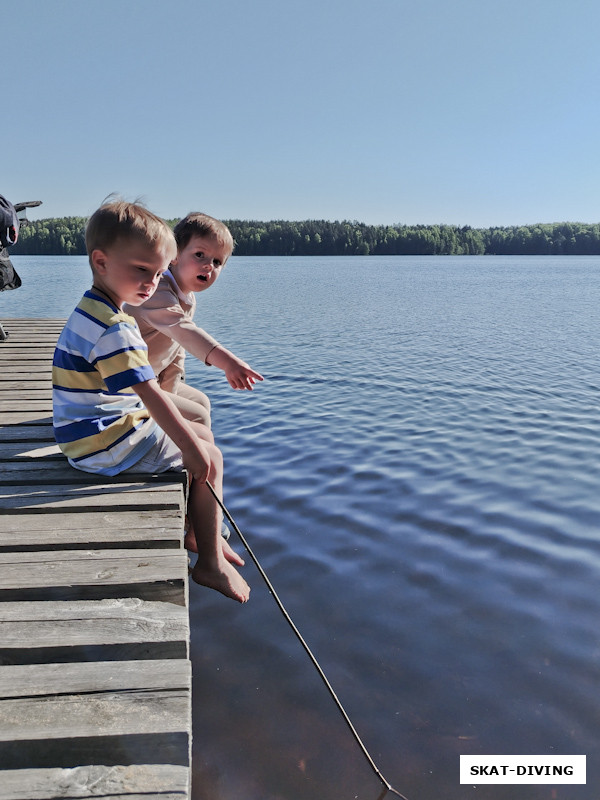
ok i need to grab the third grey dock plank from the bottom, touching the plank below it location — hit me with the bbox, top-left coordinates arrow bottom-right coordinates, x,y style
0,658 -> 192,696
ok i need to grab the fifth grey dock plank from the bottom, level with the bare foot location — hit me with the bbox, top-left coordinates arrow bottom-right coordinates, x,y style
0,548 -> 188,590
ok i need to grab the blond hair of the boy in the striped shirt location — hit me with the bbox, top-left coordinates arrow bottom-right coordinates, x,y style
85,200 -> 177,263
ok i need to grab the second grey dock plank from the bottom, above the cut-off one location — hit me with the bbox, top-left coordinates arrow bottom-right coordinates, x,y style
0,690 -> 190,742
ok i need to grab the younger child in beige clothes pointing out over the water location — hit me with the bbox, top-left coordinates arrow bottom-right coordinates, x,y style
127,213 -> 263,427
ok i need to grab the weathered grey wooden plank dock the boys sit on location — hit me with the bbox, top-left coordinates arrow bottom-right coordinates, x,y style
0,319 -> 191,800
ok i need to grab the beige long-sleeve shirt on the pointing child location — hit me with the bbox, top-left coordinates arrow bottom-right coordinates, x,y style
124,270 -> 219,391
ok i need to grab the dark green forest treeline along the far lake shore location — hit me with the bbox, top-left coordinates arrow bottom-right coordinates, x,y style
11,217 -> 600,256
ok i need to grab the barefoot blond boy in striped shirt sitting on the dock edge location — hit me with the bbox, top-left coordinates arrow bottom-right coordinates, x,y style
52,201 -> 250,602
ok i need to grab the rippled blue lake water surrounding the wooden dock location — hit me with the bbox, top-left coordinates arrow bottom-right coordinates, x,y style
0,256 -> 600,800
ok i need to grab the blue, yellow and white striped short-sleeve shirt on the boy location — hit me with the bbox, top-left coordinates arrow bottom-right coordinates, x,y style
52,290 -> 159,475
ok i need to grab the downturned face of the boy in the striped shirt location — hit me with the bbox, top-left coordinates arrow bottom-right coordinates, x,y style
92,241 -> 171,308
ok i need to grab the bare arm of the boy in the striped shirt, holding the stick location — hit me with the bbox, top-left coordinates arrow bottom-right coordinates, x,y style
133,379 -> 210,483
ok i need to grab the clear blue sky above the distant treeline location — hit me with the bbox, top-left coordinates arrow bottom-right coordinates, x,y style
0,0 -> 600,226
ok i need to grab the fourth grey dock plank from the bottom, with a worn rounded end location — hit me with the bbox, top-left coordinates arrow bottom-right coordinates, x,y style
0,597 -> 189,648
